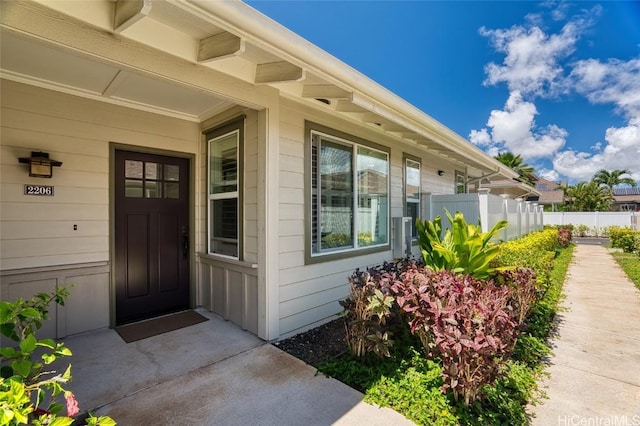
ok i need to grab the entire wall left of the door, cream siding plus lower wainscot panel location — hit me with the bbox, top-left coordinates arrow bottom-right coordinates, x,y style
0,80 -> 200,337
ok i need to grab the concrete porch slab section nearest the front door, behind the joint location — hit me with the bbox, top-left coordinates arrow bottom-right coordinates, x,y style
65,310 -> 264,411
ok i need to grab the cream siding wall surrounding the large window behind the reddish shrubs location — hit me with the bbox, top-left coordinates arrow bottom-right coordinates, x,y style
278,100 -> 456,337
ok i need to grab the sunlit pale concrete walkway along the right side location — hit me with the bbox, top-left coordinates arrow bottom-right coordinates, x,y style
532,245 -> 640,426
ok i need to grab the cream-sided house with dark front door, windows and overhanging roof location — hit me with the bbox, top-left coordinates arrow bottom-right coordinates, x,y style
0,0 -> 517,340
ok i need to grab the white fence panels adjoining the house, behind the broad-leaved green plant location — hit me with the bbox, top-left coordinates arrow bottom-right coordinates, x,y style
423,190 -> 545,241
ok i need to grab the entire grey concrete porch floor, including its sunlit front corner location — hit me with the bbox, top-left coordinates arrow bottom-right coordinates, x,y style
65,311 -> 413,426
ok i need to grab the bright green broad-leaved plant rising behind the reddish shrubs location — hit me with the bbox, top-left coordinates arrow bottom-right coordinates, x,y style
416,211 -> 508,278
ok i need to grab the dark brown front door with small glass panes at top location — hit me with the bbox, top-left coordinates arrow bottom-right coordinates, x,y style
115,150 -> 189,324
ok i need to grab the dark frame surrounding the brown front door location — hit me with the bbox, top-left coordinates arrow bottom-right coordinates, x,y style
109,142 -> 197,328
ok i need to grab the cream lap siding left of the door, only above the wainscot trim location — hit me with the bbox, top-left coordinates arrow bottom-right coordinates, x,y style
0,80 -> 199,270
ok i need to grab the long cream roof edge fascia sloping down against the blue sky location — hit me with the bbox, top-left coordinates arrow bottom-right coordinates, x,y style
188,0 -> 518,178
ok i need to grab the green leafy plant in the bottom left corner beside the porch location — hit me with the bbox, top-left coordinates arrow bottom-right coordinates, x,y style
0,287 -> 115,426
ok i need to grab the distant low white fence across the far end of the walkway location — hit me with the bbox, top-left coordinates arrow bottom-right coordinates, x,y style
544,212 -> 640,236
